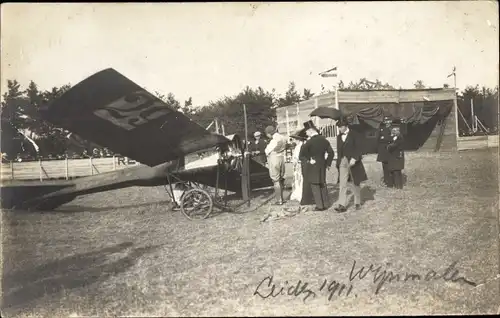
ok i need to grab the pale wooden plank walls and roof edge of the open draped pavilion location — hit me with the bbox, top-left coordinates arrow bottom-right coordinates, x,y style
276,88 -> 458,150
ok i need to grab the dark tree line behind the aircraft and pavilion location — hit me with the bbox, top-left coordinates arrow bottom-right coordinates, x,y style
0,78 -> 498,160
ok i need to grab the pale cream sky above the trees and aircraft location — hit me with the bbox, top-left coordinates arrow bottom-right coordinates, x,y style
1,1 -> 499,105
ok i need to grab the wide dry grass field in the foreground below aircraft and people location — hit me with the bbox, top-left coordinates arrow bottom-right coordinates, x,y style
2,149 -> 500,317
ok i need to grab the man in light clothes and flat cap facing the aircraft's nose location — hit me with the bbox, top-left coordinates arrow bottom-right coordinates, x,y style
264,126 -> 287,205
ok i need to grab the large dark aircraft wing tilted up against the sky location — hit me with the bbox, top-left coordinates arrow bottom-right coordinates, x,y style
41,68 -> 228,166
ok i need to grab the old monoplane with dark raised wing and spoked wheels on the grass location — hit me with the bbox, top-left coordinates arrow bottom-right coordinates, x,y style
17,68 -> 272,218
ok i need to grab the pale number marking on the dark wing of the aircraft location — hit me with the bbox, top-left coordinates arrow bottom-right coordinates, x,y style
94,91 -> 173,130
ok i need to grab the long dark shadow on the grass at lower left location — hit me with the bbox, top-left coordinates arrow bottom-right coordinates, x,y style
2,242 -> 160,307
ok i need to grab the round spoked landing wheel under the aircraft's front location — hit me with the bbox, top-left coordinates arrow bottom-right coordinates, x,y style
181,189 -> 214,220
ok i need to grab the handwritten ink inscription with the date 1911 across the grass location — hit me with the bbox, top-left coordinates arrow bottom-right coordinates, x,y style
253,261 -> 477,302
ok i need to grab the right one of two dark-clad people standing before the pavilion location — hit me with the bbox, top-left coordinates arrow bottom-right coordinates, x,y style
387,127 -> 405,189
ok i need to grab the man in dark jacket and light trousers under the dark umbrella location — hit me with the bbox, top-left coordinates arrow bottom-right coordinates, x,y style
335,118 -> 368,212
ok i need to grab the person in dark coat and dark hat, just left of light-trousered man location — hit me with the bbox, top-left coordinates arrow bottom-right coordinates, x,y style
299,121 -> 335,211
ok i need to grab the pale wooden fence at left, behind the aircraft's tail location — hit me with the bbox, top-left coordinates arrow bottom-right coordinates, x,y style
0,157 -> 138,181
